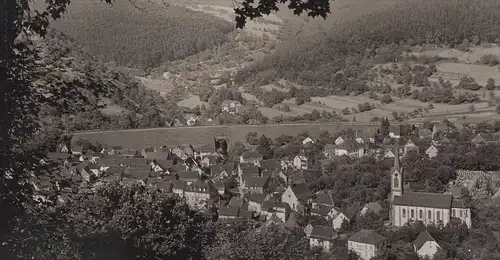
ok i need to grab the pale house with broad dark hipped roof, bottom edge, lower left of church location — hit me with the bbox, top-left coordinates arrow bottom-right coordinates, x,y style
347,229 -> 387,260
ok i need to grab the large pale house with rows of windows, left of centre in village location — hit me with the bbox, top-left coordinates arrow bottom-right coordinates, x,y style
184,180 -> 219,208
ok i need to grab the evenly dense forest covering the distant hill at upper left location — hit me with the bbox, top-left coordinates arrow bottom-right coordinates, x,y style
49,1 -> 234,69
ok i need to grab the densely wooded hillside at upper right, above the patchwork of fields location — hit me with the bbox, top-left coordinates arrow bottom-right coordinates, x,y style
237,0 -> 500,88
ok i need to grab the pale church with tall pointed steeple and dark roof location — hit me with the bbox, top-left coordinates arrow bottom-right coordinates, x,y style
389,147 -> 472,228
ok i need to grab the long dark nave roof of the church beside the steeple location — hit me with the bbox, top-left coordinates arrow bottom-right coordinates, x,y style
393,192 -> 452,209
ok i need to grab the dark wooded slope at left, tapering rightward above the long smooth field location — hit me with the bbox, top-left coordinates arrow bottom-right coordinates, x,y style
29,30 -> 183,149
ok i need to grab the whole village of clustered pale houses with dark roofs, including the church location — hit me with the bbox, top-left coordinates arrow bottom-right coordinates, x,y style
34,123 -> 500,260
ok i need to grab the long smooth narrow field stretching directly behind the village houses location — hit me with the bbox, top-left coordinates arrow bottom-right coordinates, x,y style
72,123 -> 378,149
